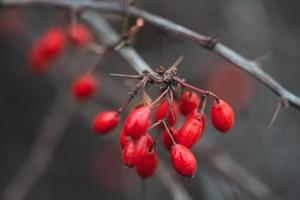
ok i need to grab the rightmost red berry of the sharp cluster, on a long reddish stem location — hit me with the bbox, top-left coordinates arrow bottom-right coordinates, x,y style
210,100 -> 234,133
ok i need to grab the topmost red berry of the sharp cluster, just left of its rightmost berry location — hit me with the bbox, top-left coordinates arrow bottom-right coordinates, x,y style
179,92 -> 200,116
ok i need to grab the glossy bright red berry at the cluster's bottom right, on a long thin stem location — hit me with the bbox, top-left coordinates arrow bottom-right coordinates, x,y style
170,144 -> 197,177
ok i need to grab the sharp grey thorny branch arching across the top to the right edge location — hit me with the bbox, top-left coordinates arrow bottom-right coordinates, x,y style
0,0 -> 300,109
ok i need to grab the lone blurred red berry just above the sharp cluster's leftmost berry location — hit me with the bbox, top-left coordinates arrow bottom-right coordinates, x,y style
72,75 -> 97,101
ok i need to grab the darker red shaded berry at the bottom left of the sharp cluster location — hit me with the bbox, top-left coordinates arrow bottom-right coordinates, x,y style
136,148 -> 158,179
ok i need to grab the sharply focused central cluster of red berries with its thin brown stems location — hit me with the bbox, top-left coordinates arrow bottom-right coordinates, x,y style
93,66 -> 234,178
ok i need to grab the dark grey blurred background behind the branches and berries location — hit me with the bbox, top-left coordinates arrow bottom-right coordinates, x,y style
0,0 -> 300,200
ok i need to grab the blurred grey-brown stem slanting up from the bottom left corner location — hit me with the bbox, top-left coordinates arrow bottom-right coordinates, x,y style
3,89 -> 76,200
